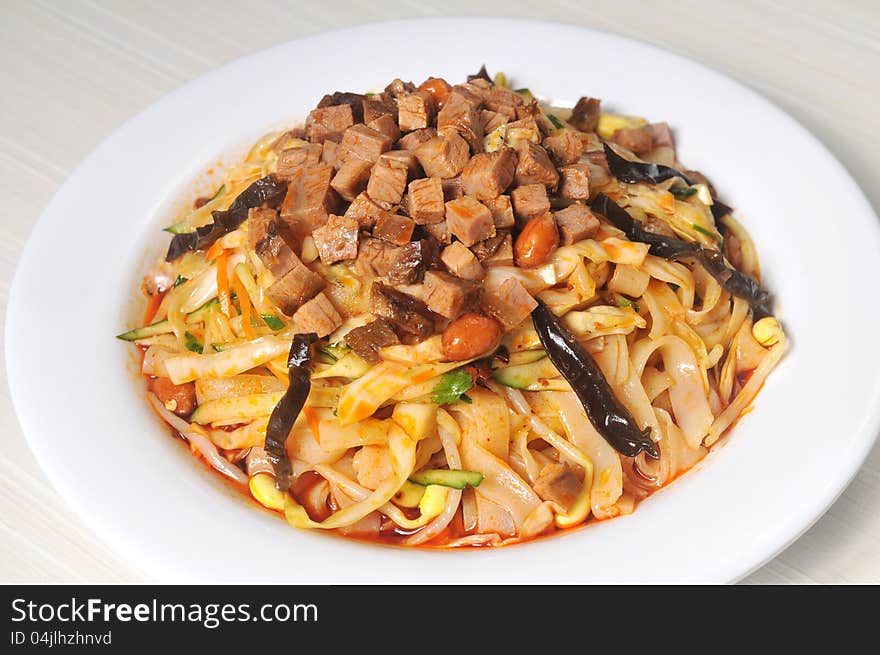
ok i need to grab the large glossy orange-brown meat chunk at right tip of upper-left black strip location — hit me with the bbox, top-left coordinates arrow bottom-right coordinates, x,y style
281,165 -> 338,239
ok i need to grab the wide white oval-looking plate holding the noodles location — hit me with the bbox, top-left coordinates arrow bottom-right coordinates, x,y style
6,19 -> 880,584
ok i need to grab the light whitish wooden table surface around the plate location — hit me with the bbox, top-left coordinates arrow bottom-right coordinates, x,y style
0,0 -> 880,583
